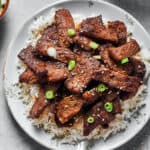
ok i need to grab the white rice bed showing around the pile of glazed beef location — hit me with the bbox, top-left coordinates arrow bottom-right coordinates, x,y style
14,9 -> 150,143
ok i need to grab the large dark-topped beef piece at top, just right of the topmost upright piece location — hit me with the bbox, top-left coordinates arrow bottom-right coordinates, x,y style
80,16 -> 118,43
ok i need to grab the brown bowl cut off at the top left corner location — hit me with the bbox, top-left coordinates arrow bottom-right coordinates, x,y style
0,0 -> 9,19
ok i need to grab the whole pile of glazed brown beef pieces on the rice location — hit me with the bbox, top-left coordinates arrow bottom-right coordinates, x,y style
18,9 -> 145,136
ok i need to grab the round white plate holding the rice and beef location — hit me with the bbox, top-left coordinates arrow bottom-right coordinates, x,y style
4,0 -> 150,150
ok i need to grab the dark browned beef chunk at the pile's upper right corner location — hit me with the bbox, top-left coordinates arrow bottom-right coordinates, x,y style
107,21 -> 127,45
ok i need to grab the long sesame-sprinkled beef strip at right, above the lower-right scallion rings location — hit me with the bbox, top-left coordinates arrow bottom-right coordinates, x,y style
94,66 -> 140,93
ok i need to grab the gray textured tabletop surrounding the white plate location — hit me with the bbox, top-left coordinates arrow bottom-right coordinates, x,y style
0,0 -> 150,150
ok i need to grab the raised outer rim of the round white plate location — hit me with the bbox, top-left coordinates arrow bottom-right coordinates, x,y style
2,0 -> 150,150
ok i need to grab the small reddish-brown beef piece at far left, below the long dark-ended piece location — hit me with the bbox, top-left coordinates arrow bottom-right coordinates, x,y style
19,68 -> 38,84
